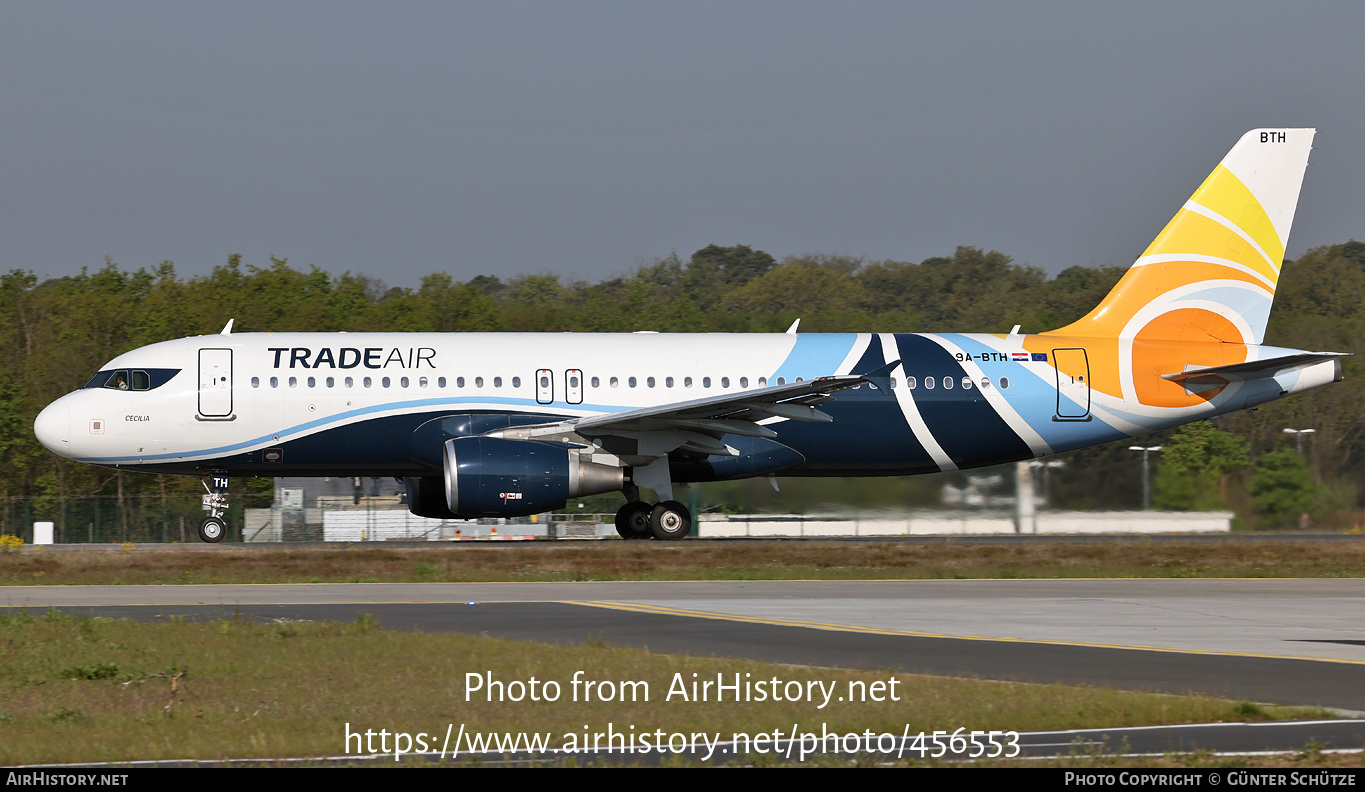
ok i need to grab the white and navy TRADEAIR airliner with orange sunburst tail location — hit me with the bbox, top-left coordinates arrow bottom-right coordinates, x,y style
34,128 -> 1342,542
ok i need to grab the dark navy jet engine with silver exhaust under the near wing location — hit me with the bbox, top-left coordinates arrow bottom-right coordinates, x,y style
445,437 -> 625,518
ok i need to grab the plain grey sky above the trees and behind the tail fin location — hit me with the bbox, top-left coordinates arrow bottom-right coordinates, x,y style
0,0 -> 1365,285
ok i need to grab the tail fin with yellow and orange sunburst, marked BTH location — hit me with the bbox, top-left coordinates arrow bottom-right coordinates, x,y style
1050,130 -> 1316,344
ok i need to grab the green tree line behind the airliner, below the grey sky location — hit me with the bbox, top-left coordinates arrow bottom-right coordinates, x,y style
0,242 -> 1365,527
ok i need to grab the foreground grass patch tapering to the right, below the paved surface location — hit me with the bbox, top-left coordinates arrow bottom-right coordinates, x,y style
0,610 -> 1320,765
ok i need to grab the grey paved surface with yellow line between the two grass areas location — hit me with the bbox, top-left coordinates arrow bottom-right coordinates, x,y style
10,579 -> 1365,711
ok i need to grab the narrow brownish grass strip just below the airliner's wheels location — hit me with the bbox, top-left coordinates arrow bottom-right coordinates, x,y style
8,538 -> 1365,586
